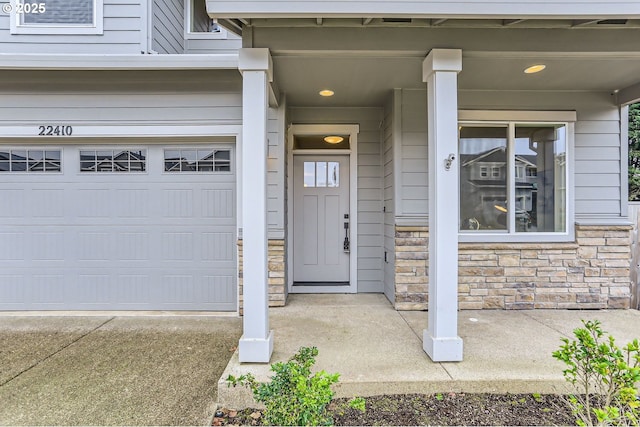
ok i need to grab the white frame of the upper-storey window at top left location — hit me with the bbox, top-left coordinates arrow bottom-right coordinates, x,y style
9,0 -> 104,35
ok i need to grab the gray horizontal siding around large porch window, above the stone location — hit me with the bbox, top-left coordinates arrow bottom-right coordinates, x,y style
398,90 -> 626,222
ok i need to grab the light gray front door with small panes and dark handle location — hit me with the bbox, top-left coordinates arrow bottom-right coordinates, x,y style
293,155 -> 351,286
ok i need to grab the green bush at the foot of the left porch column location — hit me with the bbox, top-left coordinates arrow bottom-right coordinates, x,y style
227,347 -> 340,426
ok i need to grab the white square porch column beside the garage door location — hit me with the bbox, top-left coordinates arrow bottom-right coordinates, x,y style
238,49 -> 273,363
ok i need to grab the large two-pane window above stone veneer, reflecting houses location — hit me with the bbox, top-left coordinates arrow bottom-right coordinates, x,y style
459,122 -> 568,235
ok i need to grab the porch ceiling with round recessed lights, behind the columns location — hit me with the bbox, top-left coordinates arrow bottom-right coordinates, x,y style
273,50 -> 640,106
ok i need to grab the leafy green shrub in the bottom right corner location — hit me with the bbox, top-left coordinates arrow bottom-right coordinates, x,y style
553,320 -> 640,426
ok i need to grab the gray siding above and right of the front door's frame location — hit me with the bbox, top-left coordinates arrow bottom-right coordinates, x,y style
289,108 -> 384,292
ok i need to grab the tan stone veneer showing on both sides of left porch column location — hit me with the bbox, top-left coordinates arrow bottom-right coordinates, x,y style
238,239 -> 287,314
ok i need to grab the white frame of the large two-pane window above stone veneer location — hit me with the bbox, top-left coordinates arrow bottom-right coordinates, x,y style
458,110 -> 576,243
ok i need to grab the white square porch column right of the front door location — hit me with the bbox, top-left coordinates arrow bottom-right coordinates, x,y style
422,49 -> 462,362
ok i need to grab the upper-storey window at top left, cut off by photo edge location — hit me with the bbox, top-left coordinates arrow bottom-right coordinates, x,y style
11,0 -> 103,34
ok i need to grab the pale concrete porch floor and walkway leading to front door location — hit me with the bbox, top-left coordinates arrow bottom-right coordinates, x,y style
218,294 -> 640,408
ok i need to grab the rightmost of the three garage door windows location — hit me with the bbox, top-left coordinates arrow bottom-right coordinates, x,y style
164,148 -> 231,172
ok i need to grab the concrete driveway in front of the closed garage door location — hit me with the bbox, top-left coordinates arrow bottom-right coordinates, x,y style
0,315 -> 242,425
